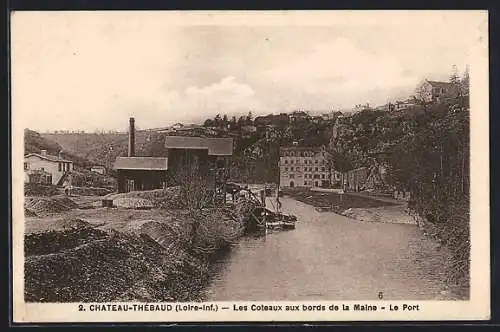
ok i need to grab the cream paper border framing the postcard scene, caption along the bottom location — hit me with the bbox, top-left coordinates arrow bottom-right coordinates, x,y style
11,11 -> 490,323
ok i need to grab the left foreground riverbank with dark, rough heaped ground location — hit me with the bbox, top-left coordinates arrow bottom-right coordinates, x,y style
24,192 -> 252,302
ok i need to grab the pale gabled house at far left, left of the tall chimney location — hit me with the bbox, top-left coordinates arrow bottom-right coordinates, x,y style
24,150 -> 73,186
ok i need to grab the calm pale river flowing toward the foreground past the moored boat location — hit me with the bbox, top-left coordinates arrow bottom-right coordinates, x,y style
205,197 -> 464,301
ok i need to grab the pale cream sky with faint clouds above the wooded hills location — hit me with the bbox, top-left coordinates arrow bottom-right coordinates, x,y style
11,11 -> 487,131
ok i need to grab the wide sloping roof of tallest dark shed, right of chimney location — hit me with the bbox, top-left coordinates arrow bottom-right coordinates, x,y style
165,136 -> 233,156
